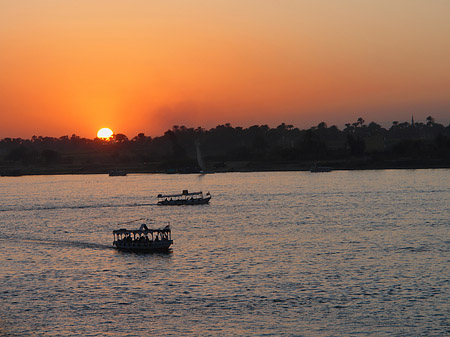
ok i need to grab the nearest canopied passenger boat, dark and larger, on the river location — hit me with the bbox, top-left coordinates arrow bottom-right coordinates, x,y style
113,224 -> 173,253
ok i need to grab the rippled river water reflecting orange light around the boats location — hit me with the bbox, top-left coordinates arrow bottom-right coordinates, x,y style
0,170 -> 450,336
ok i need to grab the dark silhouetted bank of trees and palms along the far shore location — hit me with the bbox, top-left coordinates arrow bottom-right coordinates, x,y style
0,116 -> 450,175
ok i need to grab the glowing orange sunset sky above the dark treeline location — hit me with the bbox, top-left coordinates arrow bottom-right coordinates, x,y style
0,0 -> 450,139
